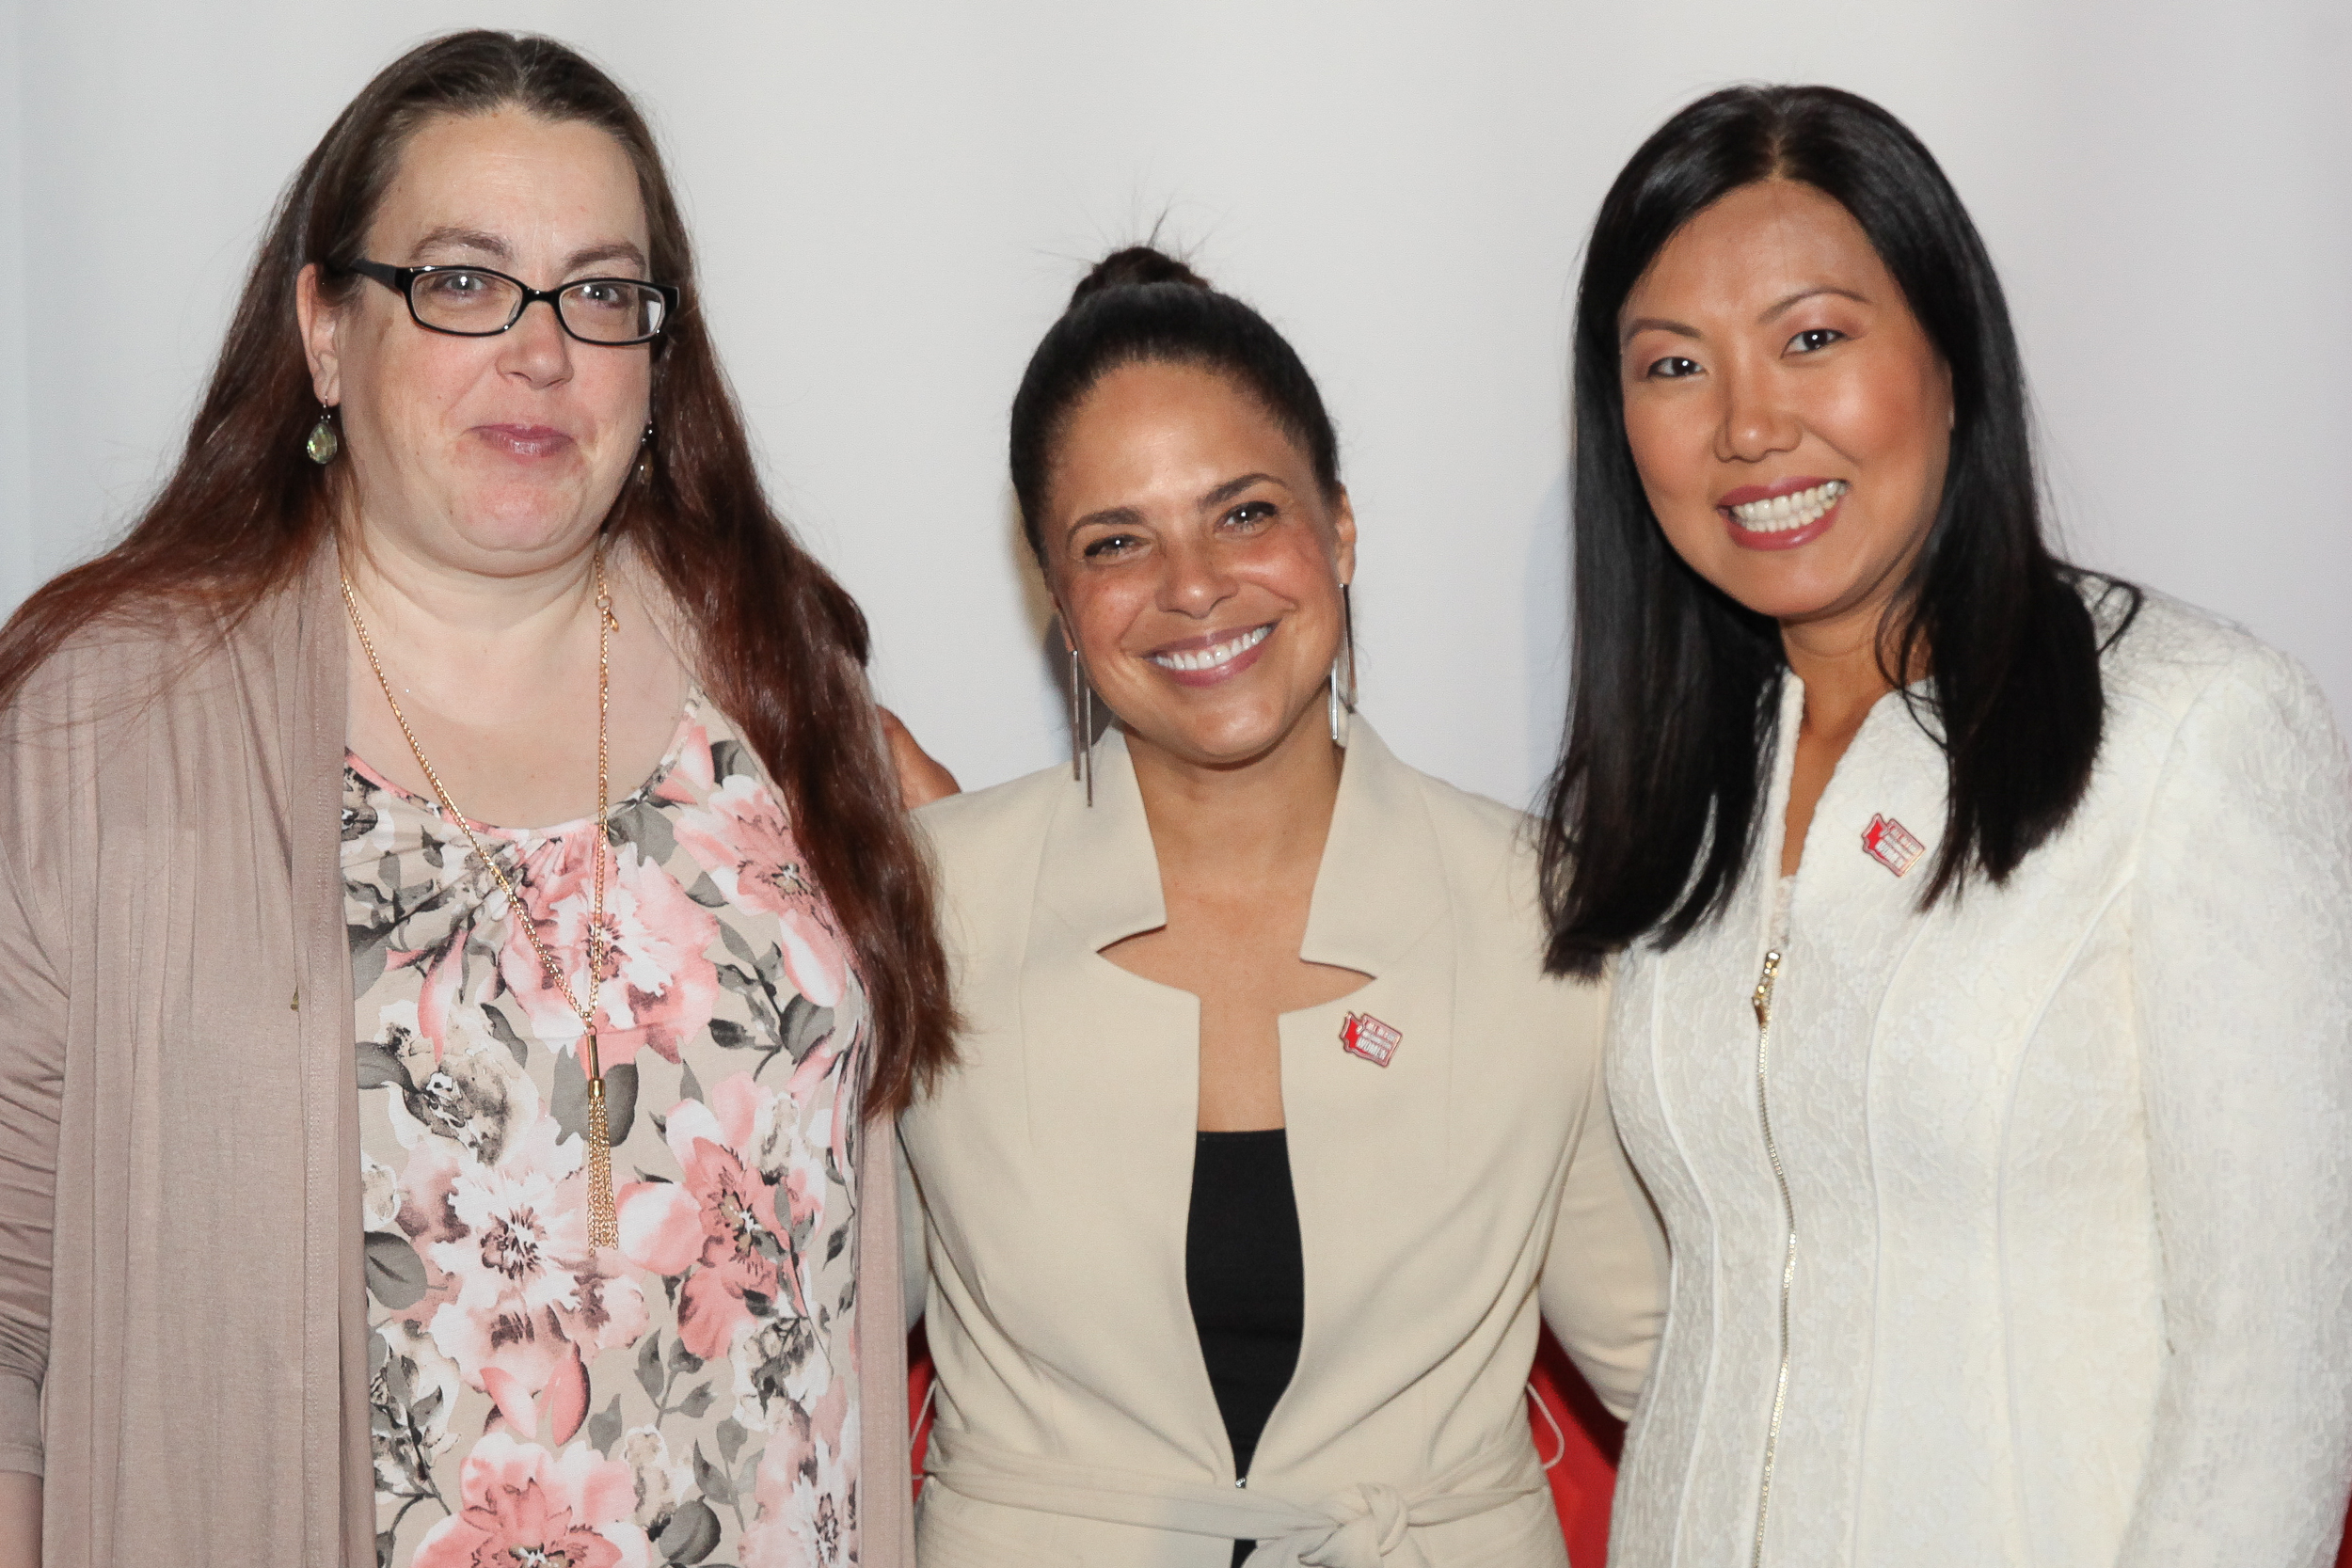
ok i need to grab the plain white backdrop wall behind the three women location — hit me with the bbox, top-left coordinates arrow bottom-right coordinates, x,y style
0,0 -> 2352,801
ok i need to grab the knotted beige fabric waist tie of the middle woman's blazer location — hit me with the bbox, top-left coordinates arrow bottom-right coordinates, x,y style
927,1427 -> 1546,1568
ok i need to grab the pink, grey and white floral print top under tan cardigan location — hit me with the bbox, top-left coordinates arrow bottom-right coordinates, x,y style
343,696 -> 866,1568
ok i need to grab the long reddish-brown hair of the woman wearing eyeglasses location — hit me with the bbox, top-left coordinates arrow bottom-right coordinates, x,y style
0,30 -> 955,1115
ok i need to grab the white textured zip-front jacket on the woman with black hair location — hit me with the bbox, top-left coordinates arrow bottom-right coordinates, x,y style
1609,594 -> 2352,1568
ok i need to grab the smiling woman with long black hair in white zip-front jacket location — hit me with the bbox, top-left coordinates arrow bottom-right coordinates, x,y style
1543,87 -> 2352,1568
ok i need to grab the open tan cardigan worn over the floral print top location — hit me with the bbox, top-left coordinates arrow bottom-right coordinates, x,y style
0,550 -> 913,1568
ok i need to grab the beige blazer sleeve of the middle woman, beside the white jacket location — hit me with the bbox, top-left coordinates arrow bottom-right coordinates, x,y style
1536,1010 -> 1665,1418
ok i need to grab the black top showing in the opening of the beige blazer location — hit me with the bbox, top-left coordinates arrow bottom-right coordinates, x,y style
1184,1126 -> 1306,1563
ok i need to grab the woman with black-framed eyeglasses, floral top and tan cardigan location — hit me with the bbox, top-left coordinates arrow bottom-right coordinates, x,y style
0,33 -> 950,1568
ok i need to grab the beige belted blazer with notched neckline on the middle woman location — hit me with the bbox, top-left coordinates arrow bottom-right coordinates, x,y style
901,720 -> 1663,1568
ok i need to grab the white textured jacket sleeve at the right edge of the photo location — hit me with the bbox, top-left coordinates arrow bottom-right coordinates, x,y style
2117,649 -> 2352,1568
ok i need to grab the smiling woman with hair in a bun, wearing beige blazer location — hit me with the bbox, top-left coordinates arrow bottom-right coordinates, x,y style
901,249 -> 1661,1568
